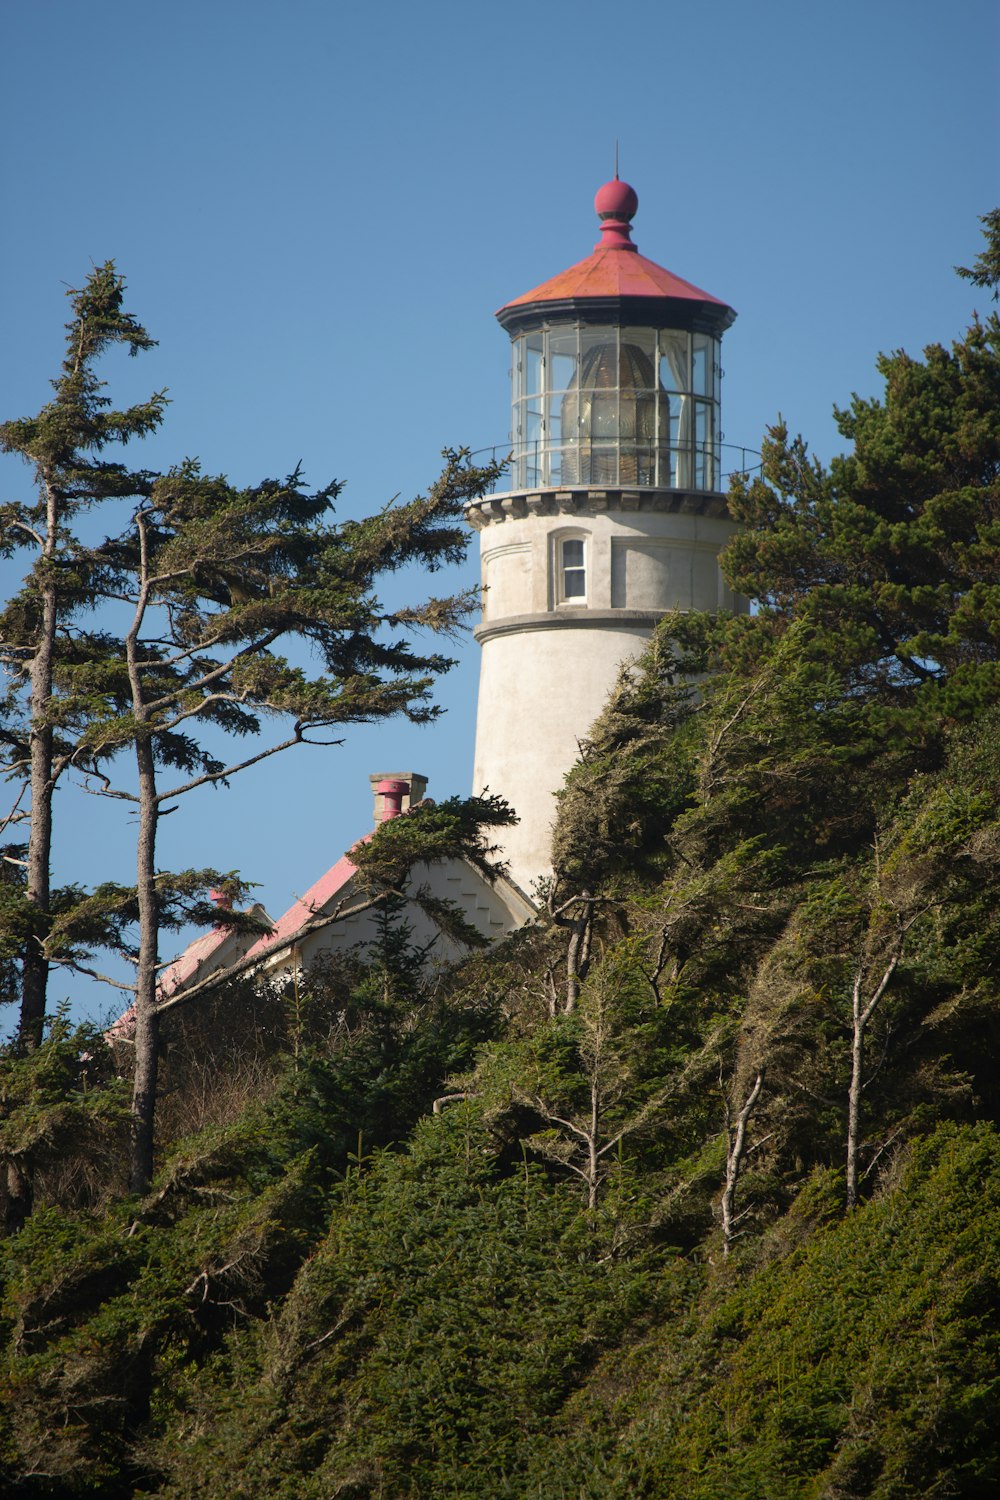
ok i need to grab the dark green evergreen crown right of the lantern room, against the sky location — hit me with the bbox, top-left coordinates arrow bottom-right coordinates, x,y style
723,215 -> 1000,722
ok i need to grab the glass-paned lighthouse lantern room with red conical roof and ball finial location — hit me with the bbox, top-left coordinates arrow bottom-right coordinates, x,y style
498,179 -> 735,491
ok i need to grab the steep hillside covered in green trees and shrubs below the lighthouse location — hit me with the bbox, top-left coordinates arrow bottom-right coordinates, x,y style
0,215 -> 1000,1500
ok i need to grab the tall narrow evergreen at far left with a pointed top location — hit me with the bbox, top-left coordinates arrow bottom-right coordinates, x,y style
0,261 -> 166,1047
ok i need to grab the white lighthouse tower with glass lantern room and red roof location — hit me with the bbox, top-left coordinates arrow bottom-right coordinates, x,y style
468,179 -> 747,891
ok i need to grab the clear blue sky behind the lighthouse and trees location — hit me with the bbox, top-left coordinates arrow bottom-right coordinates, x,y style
0,0 -> 1000,1013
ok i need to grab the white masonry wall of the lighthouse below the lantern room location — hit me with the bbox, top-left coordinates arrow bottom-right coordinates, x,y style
469,492 -> 742,891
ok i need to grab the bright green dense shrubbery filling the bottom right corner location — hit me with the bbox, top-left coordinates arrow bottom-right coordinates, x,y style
587,1128 -> 1000,1500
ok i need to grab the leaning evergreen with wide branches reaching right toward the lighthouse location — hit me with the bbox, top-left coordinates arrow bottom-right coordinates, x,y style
68,453 -> 492,1191
